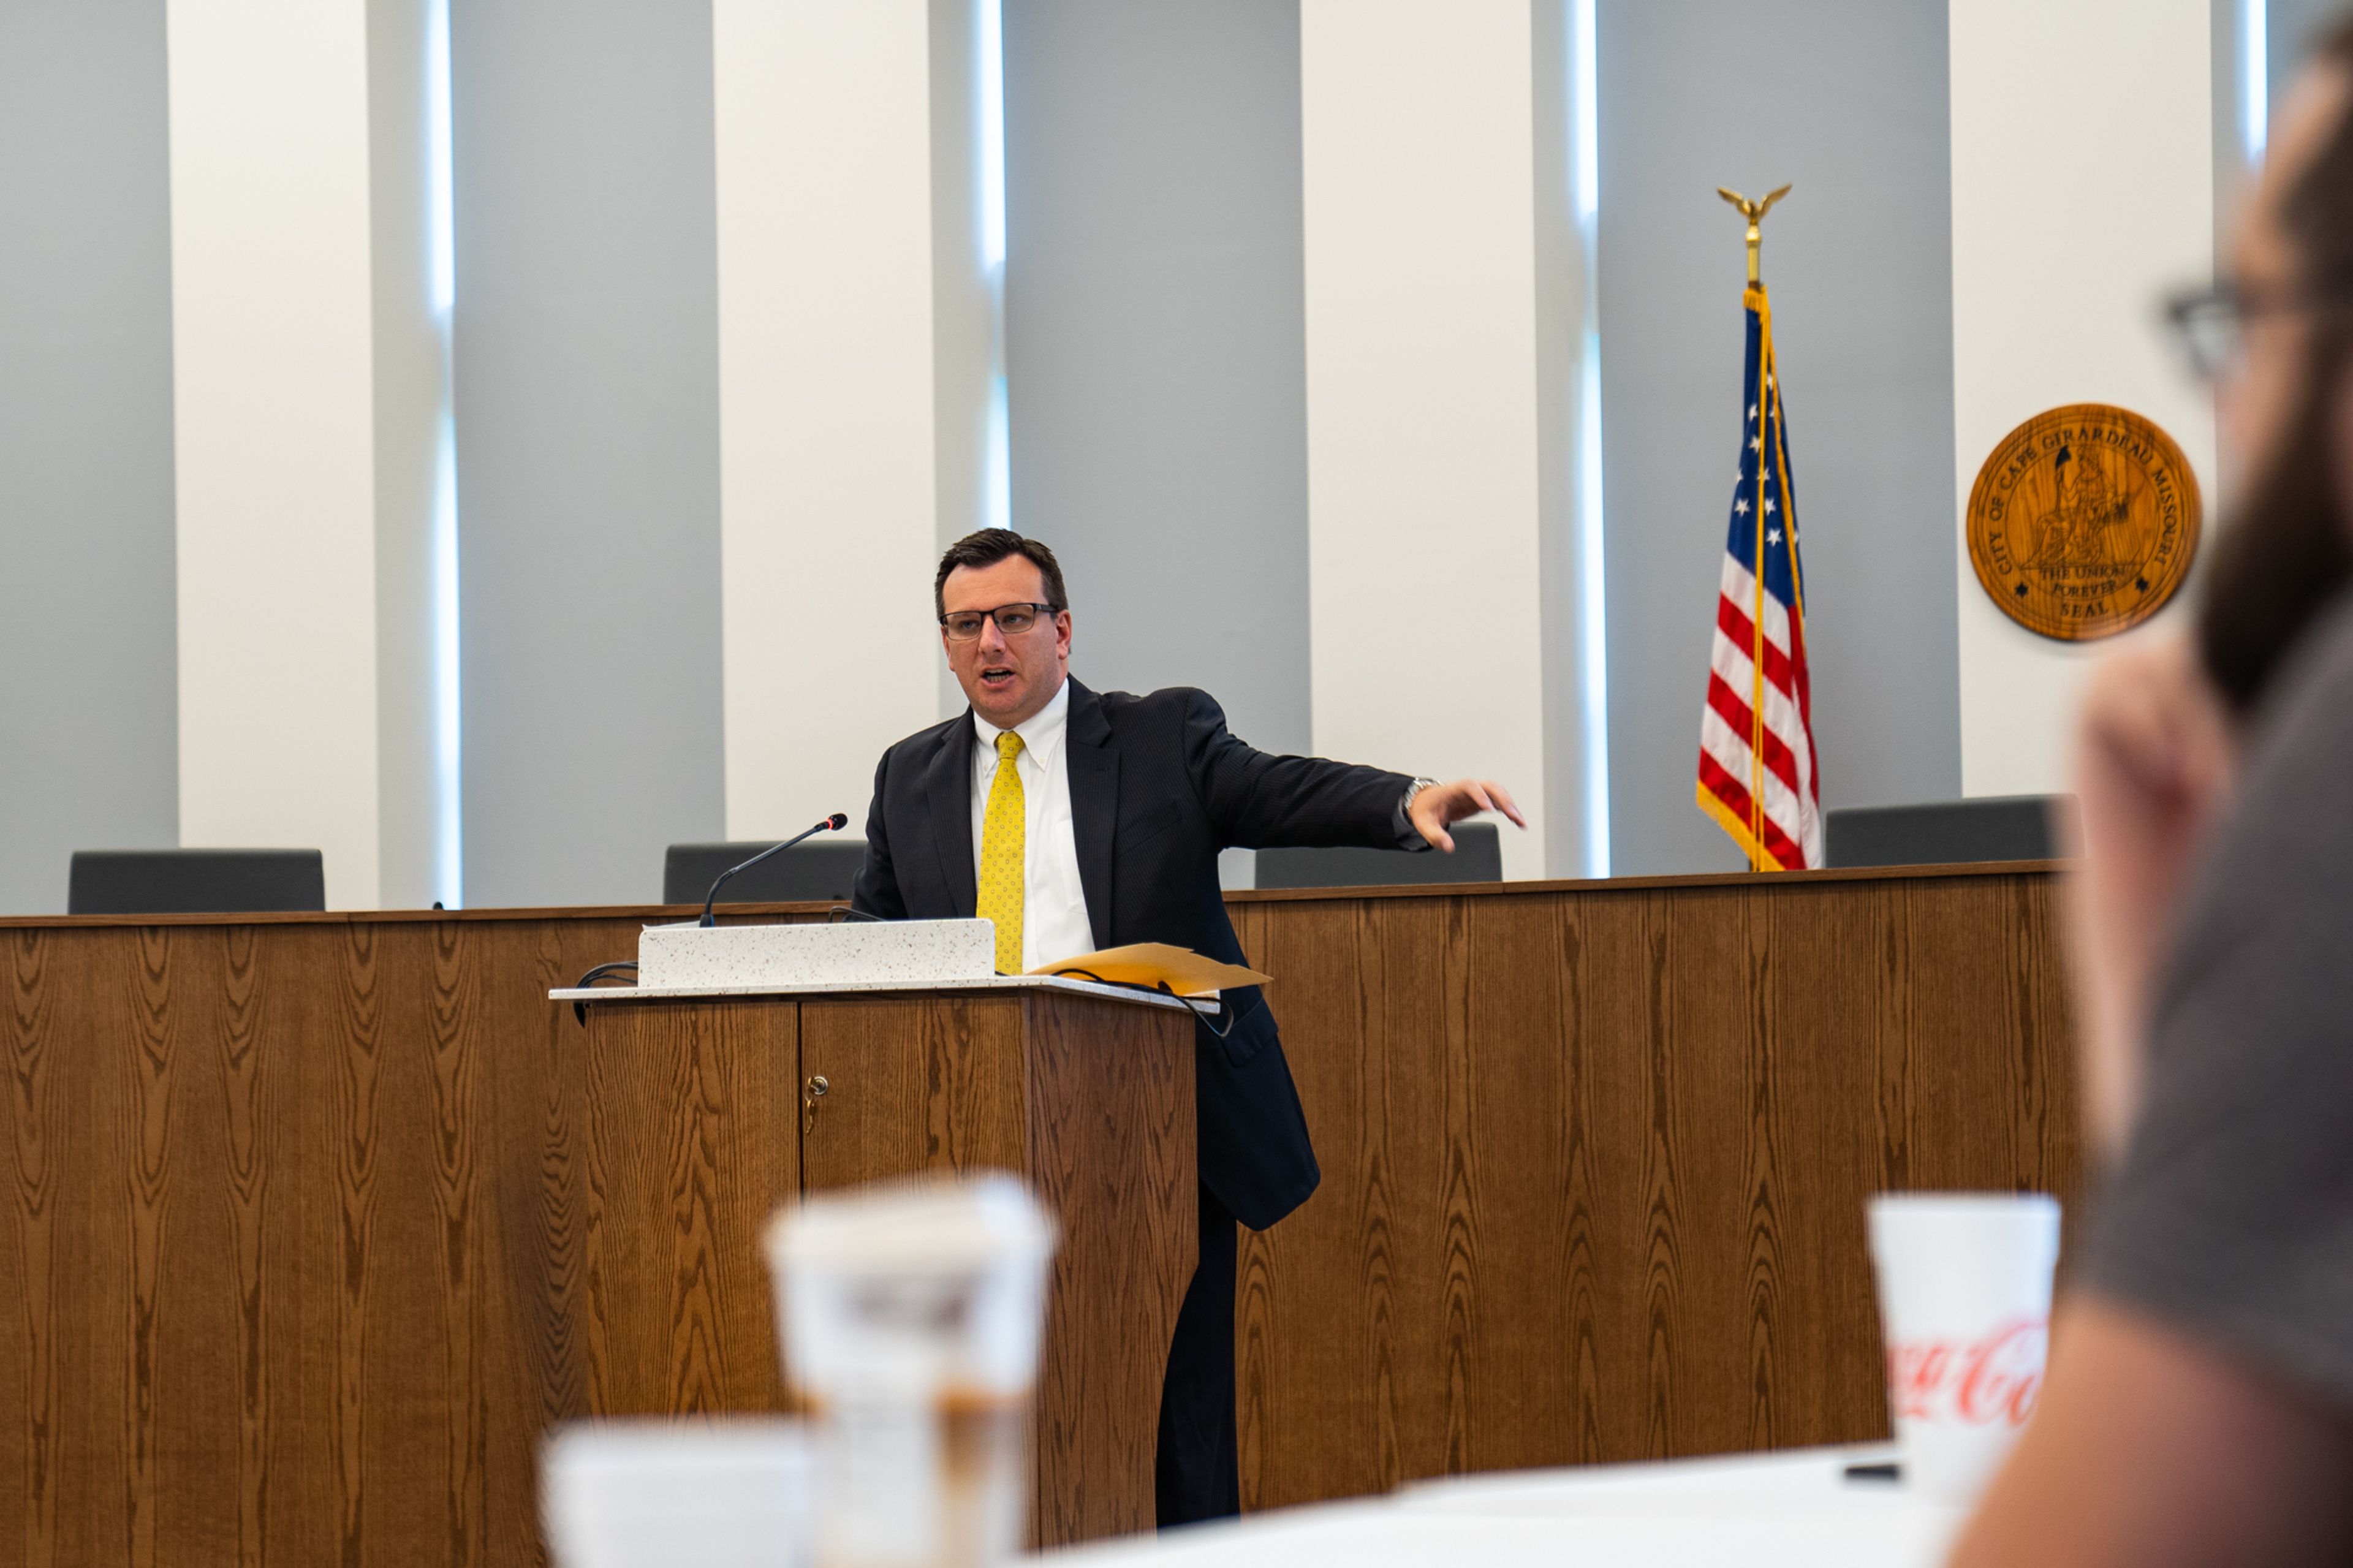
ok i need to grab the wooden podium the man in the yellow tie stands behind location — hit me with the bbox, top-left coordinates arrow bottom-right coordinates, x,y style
555,979 -> 1198,1547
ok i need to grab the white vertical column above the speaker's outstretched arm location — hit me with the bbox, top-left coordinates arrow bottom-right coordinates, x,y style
1299,0 -> 1565,878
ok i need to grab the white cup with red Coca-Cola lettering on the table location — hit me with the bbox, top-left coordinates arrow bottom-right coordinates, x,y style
1871,1194 -> 2059,1502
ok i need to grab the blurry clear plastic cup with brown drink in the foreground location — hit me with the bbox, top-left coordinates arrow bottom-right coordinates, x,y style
767,1175 -> 1054,1568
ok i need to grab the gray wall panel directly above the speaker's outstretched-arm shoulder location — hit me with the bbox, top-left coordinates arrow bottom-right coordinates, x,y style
1005,0 -> 1311,751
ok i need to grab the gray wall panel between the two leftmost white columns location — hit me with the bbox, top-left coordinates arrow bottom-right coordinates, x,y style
452,0 -> 725,906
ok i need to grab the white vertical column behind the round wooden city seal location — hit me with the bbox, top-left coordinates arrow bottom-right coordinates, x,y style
1949,0 -> 2214,796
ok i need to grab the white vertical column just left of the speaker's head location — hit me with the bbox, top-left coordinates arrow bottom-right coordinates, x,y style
713,0 -> 991,838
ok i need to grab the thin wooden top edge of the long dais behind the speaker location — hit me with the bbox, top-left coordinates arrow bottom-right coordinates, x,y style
0,859 -> 2068,930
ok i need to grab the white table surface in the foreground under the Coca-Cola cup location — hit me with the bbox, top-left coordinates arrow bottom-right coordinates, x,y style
1051,1448 -> 1963,1568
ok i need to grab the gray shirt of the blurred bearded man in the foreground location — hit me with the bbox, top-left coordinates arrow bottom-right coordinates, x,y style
2082,596 -> 2353,1412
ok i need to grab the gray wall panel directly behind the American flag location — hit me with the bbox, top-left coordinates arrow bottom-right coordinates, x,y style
1600,0 -> 1960,876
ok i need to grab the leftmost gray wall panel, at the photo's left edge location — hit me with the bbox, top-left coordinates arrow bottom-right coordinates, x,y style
0,0 -> 179,914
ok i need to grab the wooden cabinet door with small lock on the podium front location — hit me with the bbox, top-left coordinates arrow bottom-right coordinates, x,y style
800,996 -> 1028,1191
